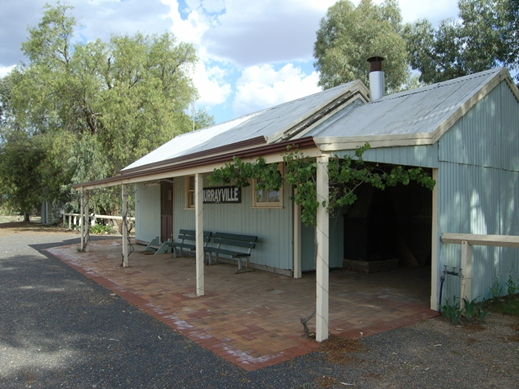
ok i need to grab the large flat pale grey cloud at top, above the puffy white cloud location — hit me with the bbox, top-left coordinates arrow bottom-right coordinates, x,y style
203,0 -> 326,67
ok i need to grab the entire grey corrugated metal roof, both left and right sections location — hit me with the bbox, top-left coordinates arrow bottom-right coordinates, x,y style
122,68 -> 508,173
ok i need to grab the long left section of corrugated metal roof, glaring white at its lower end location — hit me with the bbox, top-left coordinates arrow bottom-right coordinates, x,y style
122,82 -> 354,172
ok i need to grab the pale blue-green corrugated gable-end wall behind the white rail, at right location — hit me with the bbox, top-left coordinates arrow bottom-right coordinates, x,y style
437,82 -> 519,302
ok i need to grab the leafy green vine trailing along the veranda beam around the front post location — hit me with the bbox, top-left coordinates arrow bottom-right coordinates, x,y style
210,143 -> 436,226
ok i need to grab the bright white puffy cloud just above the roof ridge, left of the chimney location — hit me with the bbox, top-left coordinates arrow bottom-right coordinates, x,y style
233,63 -> 321,116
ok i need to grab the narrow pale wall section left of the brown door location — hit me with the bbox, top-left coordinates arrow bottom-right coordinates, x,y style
135,183 -> 160,242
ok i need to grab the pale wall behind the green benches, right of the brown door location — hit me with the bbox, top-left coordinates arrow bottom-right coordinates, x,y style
173,177 -> 293,271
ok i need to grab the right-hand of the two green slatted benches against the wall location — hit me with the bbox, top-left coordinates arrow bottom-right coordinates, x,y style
204,232 -> 258,273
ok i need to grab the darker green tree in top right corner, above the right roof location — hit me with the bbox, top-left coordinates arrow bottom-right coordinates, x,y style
403,0 -> 519,83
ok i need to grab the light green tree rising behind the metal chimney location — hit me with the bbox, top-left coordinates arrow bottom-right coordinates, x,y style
314,0 -> 410,91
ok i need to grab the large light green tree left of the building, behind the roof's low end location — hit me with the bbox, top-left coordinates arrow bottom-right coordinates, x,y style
0,3 -> 212,215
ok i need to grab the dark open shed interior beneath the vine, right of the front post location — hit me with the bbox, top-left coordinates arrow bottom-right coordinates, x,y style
343,181 -> 432,267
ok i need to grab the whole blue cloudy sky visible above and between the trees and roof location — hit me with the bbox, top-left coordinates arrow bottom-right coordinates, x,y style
0,0 -> 458,123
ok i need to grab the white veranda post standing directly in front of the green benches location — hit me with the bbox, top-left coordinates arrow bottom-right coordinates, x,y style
195,174 -> 205,296
